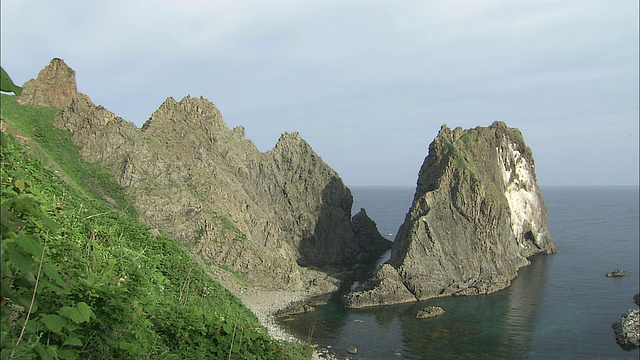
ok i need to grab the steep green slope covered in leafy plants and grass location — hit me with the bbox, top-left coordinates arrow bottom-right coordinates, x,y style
1,94 -> 305,359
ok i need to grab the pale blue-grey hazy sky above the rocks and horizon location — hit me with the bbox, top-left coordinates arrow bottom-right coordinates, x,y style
0,0 -> 639,186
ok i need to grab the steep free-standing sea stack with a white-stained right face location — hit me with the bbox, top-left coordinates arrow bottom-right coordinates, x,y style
344,122 -> 556,307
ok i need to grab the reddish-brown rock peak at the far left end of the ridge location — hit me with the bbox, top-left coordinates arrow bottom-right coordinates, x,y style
17,58 -> 89,109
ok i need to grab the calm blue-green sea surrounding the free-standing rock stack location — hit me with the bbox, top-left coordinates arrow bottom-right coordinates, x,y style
280,187 -> 640,359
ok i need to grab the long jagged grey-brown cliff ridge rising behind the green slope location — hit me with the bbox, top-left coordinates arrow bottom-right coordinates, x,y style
23,61 -> 391,292
